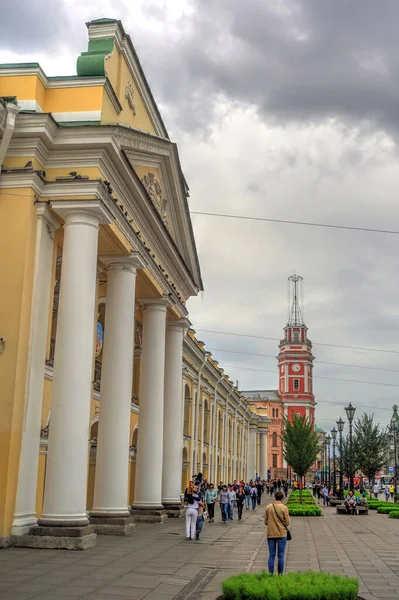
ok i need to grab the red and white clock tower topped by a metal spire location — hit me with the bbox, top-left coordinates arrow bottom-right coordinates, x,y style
277,275 -> 315,423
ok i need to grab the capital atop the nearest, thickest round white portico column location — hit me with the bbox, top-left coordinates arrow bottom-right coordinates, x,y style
51,200 -> 113,226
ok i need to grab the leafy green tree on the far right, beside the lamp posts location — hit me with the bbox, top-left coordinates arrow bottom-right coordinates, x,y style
353,414 -> 389,487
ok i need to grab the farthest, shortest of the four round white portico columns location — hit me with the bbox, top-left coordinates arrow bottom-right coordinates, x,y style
162,320 -> 188,511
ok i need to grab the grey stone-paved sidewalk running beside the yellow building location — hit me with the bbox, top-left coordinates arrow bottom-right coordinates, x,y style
0,506 -> 399,600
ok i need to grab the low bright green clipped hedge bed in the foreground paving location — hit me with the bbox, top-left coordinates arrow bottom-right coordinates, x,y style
222,571 -> 359,600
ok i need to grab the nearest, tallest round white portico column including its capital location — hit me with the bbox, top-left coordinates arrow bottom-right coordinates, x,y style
39,201 -> 110,526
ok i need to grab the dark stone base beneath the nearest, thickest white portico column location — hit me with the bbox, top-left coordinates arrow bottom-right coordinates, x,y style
12,525 -> 97,550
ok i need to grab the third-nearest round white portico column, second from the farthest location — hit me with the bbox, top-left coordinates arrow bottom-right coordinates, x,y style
133,298 -> 168,516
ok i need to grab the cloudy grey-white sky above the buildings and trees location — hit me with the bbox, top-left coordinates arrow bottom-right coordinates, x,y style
0,0 -> 399,428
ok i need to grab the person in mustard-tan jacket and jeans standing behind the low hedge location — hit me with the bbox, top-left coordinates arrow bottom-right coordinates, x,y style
265,491 -> 290,575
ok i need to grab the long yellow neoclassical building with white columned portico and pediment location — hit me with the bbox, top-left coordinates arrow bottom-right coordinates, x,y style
0,19 -> 267,548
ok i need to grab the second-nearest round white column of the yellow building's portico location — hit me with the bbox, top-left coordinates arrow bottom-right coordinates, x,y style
90,254 -> 145,517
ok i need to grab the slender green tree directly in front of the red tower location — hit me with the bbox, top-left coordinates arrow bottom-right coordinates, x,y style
281,414 -> 320,504
